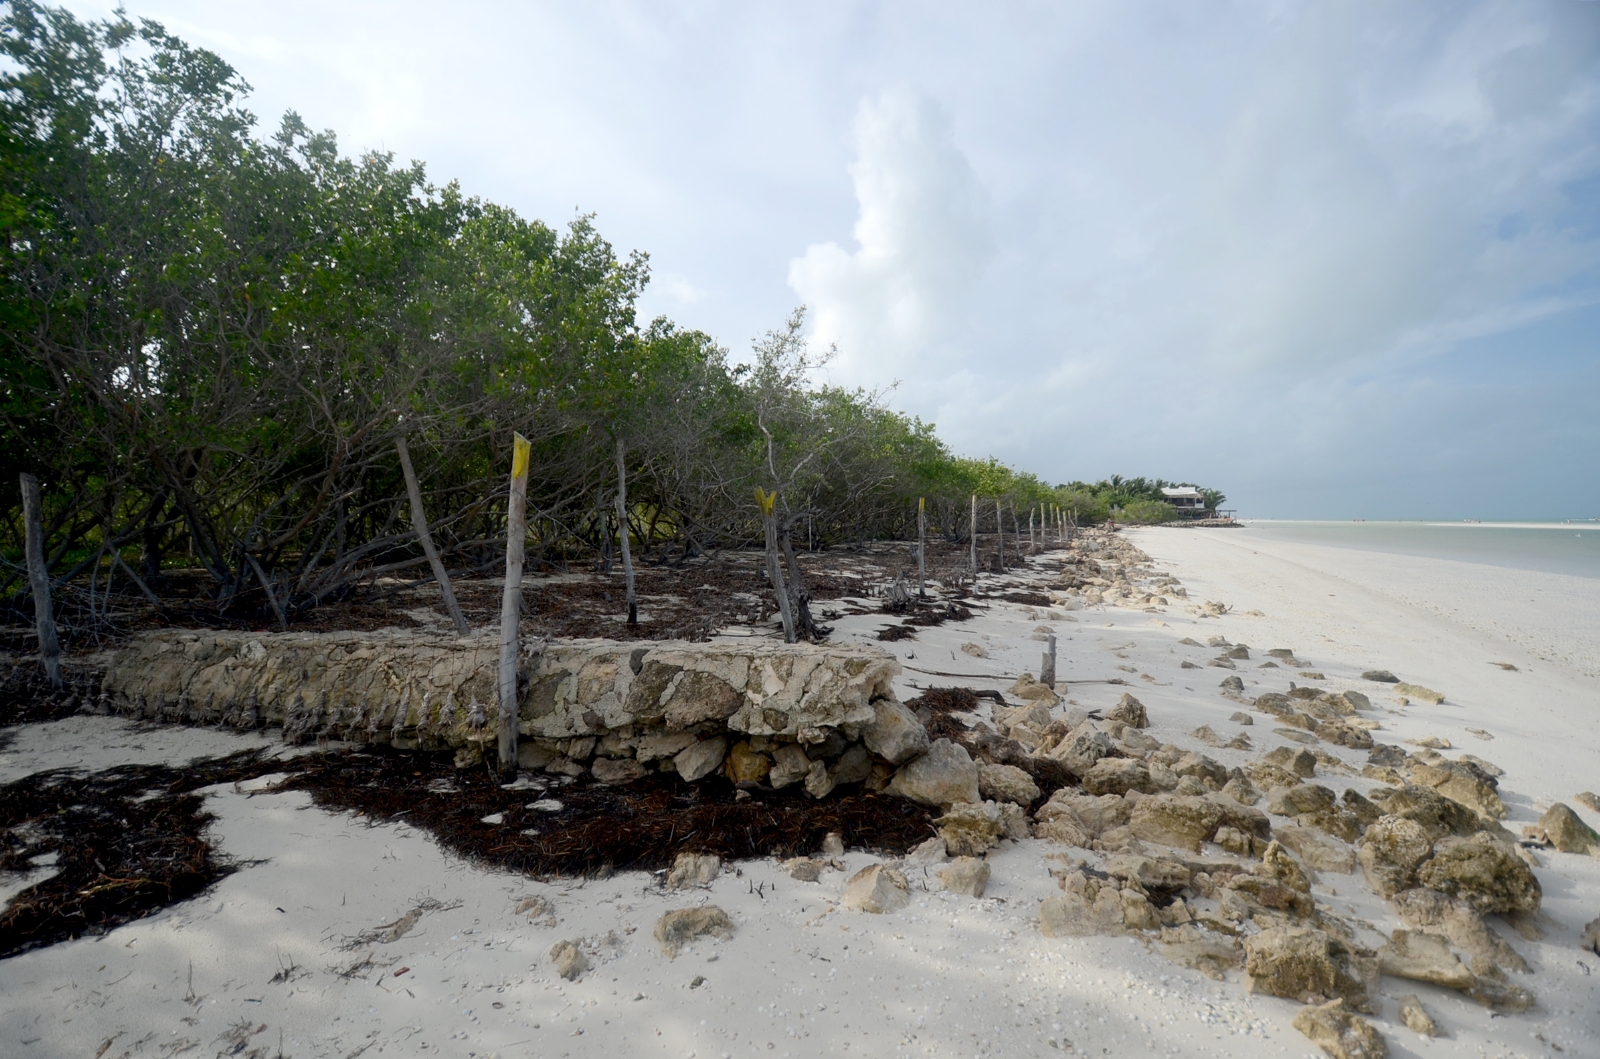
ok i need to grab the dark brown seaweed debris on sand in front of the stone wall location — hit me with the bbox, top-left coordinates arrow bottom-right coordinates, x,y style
0,747 -> 933,958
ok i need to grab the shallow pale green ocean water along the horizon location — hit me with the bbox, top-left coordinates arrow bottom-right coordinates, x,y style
1243,518 -> 1600,579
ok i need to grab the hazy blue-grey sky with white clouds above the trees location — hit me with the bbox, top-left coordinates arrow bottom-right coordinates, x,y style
69,0 -> 1600,518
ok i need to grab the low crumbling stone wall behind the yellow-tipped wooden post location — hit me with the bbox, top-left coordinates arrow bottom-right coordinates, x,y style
101,630 -> 904,793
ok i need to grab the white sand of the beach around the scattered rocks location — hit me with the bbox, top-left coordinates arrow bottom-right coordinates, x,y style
0,531 -> 1600,1059
